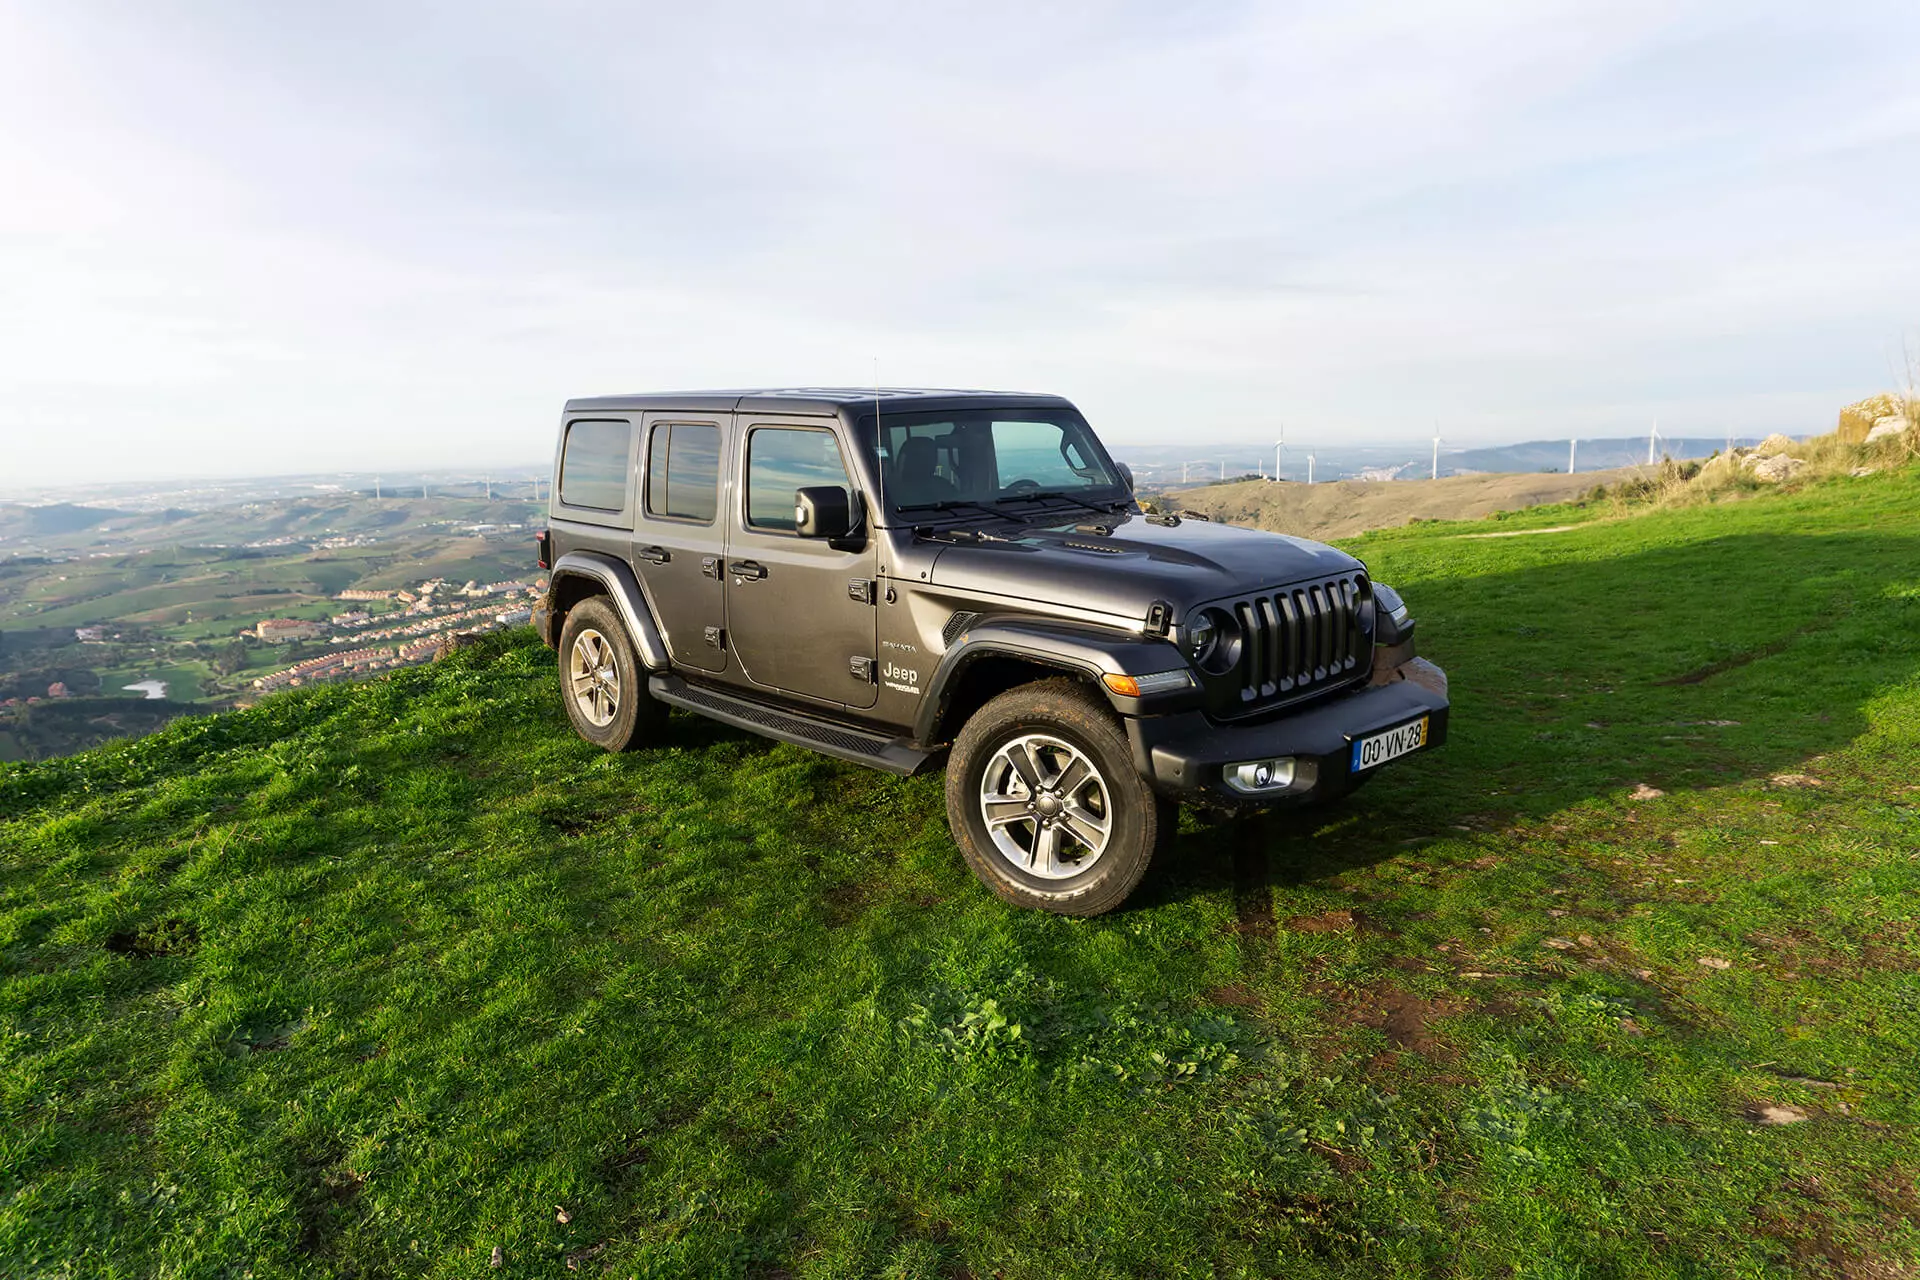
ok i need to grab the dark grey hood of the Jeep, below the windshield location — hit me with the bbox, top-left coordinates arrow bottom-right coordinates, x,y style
929,512 -> 1359,618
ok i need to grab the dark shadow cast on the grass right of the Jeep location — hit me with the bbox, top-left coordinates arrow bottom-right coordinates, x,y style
1129,532 -> 1920,913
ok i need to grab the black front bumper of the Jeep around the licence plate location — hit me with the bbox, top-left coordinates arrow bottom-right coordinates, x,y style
1127,658 -> 1448,808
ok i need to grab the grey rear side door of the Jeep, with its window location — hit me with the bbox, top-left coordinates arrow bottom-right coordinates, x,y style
634,413 -> 732,672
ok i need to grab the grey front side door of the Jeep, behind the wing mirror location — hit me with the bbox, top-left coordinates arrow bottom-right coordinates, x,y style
726,415 -> 879,708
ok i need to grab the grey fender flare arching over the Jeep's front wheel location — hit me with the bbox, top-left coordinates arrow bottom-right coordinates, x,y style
914,618 -> 1200,743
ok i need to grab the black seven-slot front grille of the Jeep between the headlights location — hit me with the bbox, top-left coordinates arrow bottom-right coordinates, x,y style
1231,574 -> 1373,710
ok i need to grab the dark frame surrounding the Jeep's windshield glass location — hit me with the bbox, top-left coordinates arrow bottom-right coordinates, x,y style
860,403 -> 1133,528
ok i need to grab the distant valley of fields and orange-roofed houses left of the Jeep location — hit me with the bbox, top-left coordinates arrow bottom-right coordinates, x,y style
0,495 -> 536,760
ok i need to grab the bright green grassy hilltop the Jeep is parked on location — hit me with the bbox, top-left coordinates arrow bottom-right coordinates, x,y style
0,468 -> 1920,1278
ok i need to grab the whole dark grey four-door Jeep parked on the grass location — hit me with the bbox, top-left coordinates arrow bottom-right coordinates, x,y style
534,390 -> 1448,915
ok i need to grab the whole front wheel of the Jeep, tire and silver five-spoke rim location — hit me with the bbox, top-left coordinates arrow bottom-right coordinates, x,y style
947,679 -> 1177,915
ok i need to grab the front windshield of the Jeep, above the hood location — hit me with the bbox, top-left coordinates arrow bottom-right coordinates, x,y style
877,409 -> 1127,516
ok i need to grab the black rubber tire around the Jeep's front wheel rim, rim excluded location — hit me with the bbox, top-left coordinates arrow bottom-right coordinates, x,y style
947,679 -> 1179,915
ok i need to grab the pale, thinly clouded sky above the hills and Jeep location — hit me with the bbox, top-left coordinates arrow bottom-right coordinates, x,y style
0,0 -> 1920,487
